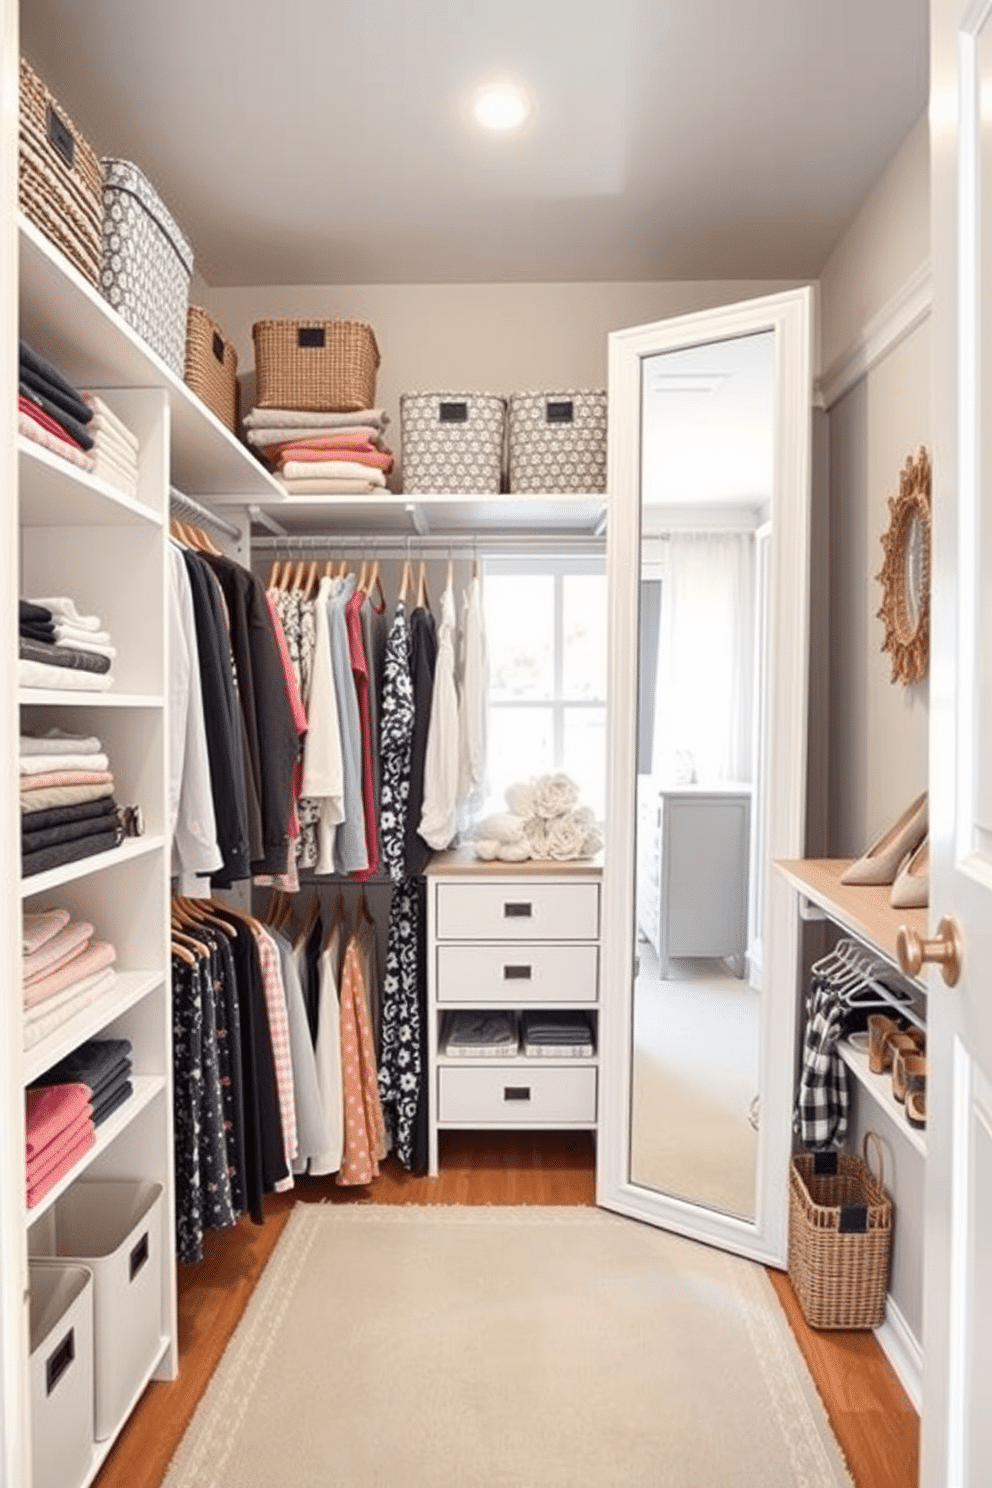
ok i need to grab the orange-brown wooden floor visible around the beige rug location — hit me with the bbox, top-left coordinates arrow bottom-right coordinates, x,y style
95,1132 -> 919,1488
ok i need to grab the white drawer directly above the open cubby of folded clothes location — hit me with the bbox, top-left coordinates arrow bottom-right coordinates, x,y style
436,940 -> 599,1007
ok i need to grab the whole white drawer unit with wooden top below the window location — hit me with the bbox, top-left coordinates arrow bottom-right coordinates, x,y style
427,853 -> 602,1177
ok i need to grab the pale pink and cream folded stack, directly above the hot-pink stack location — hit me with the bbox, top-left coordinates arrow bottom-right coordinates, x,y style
21,909 -> 117,1049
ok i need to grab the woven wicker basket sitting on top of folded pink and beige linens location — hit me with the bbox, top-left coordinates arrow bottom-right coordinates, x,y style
251,320 -> 379,414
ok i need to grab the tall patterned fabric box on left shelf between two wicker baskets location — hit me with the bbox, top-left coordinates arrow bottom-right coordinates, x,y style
100,156 -> 193,378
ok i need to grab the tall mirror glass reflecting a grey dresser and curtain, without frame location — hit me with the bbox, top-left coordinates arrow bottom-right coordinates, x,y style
629,330 -> 773,1220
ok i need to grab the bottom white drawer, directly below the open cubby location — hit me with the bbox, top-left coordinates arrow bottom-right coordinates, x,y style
437,1059 -> 598,1126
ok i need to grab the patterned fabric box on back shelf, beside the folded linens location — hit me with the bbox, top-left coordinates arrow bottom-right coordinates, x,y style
400,393 -> 506,496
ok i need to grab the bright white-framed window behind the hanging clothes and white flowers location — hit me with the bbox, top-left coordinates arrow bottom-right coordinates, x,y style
483,554 -> 607,820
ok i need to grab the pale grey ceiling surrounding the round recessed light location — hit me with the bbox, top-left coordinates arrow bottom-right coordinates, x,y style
21,0 -> 927,286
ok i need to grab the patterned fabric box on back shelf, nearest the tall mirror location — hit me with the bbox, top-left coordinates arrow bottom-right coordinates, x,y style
507,391 -> 607,493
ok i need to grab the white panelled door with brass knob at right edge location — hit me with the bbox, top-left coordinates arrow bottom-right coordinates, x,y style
922,0 -> 992,1488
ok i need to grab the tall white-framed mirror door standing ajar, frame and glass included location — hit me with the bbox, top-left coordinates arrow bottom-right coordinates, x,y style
596,290 -> 811,1265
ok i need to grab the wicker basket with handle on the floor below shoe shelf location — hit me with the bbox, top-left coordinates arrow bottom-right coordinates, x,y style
788,1131 -> 892,1329
